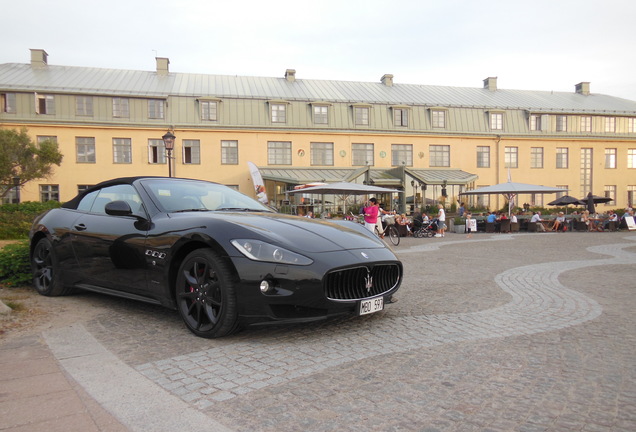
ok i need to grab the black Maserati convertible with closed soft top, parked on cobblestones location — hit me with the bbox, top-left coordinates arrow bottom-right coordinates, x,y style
30,177 -> 403,338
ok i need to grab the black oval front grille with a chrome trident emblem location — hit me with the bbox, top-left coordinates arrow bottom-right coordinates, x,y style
324,264 -> 402,300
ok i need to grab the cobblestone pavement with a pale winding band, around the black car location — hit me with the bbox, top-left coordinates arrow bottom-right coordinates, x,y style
43,232 -> 636,431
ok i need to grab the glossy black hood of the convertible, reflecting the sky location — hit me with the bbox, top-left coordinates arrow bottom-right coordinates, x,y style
176,212 -> 386,252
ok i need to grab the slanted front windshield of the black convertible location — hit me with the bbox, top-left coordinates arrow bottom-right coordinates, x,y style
141,179 -> 272,213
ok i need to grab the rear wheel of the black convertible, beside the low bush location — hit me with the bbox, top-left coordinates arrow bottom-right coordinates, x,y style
31,238 -> 69,297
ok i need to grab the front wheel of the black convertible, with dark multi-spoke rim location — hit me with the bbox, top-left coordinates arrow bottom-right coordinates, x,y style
176,249 -> 238,338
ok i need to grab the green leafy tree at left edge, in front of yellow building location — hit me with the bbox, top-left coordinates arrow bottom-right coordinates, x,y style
0,128 -> 64,198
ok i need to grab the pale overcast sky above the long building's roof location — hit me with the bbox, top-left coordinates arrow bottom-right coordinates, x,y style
0,0 -> 636,101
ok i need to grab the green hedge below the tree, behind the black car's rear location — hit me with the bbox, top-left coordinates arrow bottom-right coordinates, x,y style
0,201 -> 60,240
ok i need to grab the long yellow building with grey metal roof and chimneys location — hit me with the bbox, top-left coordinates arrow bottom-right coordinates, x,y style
0,50 -> 636,212
